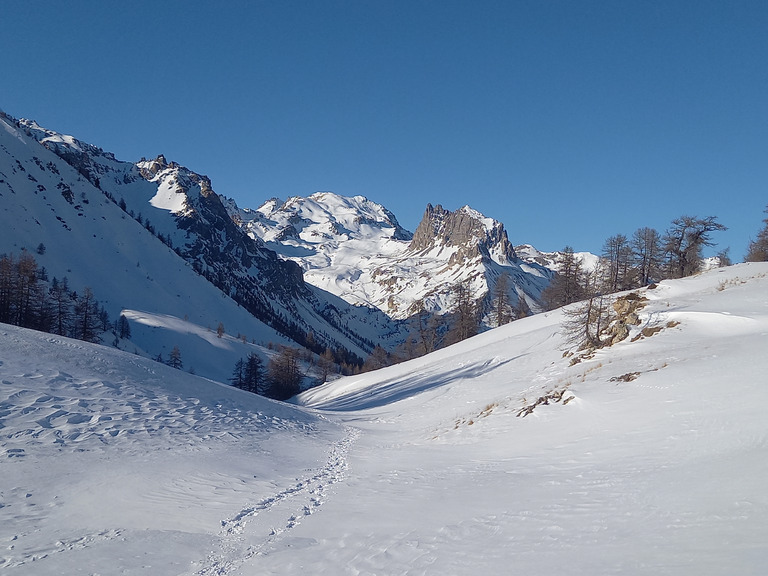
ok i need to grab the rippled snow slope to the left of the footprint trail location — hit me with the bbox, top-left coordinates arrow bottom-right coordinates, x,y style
0,326 -> 342,574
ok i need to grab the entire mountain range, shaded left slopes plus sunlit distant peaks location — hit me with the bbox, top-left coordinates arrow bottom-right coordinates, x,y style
0,114 -> 568,379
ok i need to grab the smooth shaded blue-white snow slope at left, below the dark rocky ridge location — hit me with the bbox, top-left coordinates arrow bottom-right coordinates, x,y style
0,113 -> 298,379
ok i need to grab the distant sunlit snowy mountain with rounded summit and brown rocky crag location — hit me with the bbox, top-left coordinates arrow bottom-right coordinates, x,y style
228,192 -> 552,325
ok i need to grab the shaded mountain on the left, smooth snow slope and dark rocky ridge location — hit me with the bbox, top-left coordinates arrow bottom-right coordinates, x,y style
0,116 -> 404,379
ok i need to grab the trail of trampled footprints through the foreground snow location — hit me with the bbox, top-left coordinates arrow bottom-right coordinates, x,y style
192,426 -> 360,576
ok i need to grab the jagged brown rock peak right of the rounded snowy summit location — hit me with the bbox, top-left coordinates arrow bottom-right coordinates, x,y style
409,204 -> 517,264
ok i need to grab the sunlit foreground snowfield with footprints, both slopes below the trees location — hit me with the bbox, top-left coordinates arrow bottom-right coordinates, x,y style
0,264 -> 768,576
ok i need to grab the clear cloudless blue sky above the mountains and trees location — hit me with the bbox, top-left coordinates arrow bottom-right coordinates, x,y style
0,0 -> 768,261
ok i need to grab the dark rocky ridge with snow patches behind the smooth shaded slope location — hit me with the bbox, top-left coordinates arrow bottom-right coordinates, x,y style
17,120 -> 394,357
